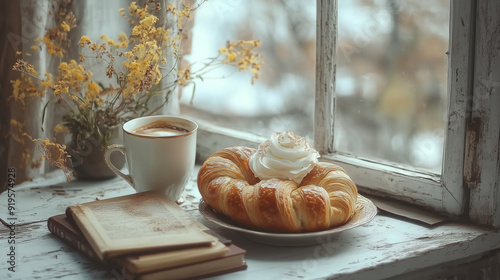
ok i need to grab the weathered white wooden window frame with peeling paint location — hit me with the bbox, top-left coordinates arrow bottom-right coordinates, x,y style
189,0 -> 500,227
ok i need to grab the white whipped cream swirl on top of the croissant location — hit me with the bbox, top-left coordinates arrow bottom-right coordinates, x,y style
249,130 -> 320,184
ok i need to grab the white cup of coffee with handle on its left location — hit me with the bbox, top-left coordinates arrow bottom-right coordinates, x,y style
104,115 -> 198,201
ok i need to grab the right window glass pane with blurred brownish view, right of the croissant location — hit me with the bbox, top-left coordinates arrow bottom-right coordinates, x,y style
334,0 -> 450,173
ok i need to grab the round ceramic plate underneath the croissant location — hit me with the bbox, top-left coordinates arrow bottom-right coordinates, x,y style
199,195 -> 377,246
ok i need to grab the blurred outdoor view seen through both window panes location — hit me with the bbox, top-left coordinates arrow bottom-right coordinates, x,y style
180,0 -> 450,173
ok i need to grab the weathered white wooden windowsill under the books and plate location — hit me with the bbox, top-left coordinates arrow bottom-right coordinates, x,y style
0,170 -> 500,280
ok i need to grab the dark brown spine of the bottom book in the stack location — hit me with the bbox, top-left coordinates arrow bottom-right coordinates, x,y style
47,218 -> 105,265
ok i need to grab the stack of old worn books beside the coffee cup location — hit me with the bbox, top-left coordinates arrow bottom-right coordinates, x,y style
47,192 -> 247,280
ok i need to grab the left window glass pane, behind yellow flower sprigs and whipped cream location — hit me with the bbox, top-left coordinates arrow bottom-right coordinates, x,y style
180,0 -> 316,142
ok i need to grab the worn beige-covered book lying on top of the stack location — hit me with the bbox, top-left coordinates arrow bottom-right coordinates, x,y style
66,192 -> 217,260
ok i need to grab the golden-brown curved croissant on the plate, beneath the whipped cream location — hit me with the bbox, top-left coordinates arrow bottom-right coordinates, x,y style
198,147 -> 358,232
